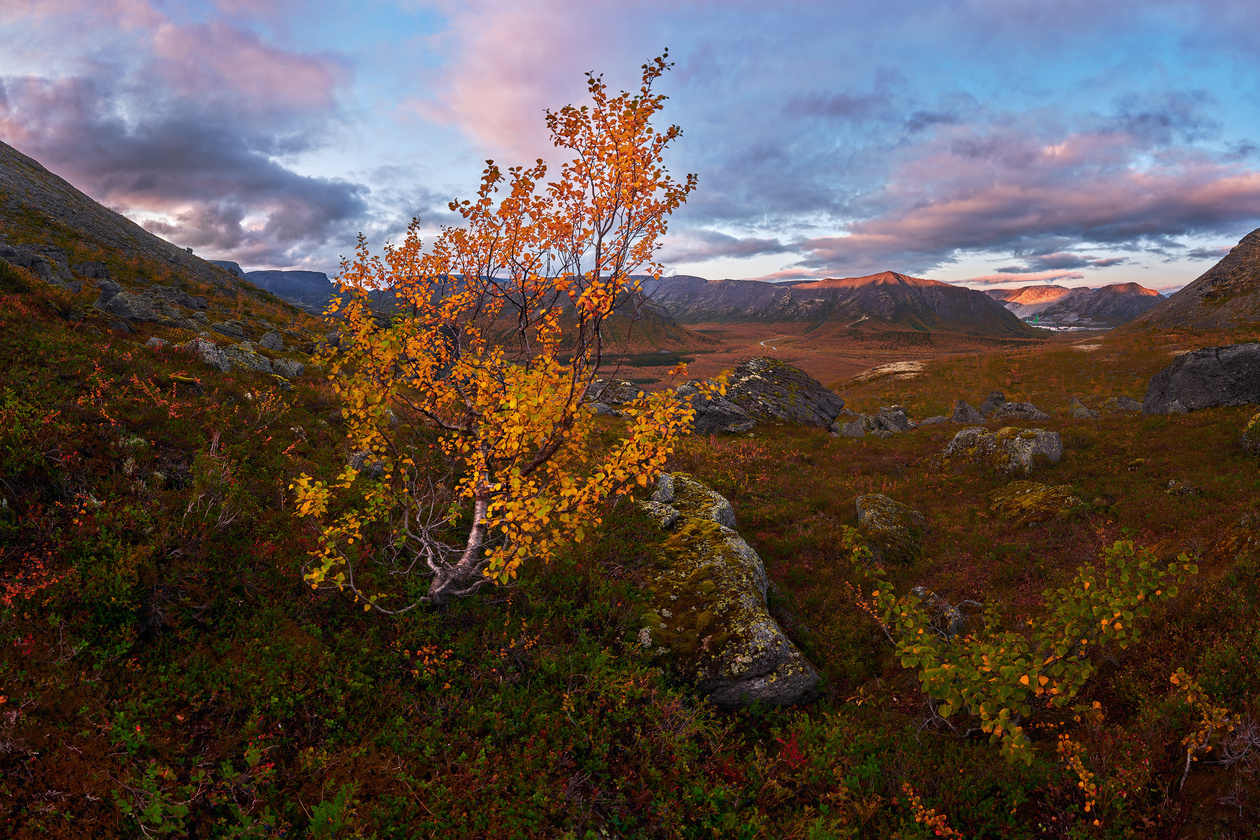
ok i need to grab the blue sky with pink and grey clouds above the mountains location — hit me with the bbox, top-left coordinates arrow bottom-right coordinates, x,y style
0,0 -> 1260,292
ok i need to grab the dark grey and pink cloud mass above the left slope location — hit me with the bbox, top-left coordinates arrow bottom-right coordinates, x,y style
0,0 -> 369,266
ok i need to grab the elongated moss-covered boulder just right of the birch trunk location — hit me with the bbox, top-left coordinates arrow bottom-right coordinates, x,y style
639,474 -> 819,707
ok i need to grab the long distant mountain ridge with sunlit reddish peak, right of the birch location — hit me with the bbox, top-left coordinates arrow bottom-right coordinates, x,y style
644,271 -> 1037,338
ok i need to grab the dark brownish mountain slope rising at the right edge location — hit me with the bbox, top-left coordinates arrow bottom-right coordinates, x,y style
1134,229 -> 1260,330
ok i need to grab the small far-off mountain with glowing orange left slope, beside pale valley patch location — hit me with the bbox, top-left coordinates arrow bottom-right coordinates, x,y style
985,283 -> 1164,329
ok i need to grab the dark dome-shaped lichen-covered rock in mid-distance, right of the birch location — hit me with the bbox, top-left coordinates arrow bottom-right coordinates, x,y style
726,358 -> 844,428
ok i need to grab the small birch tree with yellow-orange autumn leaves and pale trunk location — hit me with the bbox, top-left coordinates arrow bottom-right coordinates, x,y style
292,55 -> 715,613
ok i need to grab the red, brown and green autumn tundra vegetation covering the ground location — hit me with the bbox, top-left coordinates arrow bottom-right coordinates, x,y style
0,62 -> 1260,837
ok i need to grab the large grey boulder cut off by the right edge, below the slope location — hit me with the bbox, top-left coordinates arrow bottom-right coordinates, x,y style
1142,344 -> 1260,414
